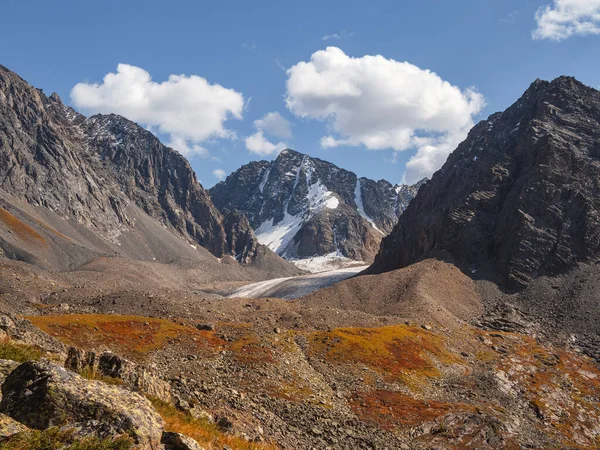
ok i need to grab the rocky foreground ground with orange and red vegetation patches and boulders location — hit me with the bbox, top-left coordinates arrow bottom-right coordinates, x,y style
0,260 -> 600,450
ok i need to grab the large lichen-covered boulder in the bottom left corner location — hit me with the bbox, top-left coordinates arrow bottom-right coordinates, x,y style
0,360 -> 164,450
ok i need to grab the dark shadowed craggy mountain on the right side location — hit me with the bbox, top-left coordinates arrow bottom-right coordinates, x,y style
370,77 -> 600,288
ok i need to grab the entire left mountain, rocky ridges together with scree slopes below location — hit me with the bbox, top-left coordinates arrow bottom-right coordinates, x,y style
0,66 -> 296,269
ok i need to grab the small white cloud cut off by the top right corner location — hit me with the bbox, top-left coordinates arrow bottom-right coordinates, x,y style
533,0 -> 600,41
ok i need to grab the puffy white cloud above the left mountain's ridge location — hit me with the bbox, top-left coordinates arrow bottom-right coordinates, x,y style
71,64 -> 244,155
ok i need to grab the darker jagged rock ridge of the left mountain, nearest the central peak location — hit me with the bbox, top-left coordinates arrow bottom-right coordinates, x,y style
83,114 -> 229,256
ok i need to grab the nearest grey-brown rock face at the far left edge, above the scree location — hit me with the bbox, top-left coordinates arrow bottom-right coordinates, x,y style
0,66 -> 129,234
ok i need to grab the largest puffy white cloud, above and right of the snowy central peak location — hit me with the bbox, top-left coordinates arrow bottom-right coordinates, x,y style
286,47 -> 485,182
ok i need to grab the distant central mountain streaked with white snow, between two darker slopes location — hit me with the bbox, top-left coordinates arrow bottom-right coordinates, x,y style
209,149 -> 425,268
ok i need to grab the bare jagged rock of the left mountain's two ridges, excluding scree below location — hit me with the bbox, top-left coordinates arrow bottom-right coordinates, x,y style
0,66 -> 257,262
